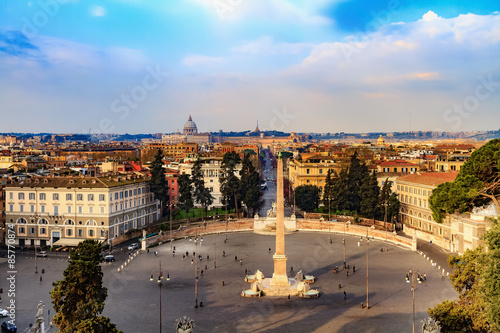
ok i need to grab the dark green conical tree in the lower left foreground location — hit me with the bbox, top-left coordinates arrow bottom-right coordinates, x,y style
50,239 -> 121,333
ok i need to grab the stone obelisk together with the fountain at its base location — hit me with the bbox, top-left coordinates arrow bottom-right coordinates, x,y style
242,153 -> 319,297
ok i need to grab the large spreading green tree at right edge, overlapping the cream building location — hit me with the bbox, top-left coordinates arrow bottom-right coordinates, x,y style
429,139 -> 500,222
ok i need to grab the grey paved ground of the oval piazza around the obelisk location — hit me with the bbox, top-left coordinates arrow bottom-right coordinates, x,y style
0,232 -> 457,332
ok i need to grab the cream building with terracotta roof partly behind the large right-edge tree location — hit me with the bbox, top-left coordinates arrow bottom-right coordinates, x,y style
396,172 -> 487,253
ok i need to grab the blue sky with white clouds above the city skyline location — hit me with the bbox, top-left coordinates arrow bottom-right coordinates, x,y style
0,0 -> 500,133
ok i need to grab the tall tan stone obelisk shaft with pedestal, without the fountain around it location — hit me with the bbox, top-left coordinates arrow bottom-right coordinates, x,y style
271,152 -> 290,287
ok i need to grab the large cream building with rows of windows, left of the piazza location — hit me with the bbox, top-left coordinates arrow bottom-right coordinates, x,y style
5,176 -> 160,246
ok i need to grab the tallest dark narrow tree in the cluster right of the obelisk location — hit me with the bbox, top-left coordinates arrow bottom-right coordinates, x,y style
346,152 -> 370,212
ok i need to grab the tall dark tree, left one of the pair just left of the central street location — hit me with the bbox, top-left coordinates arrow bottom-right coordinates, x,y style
219,151 -> 241,216
